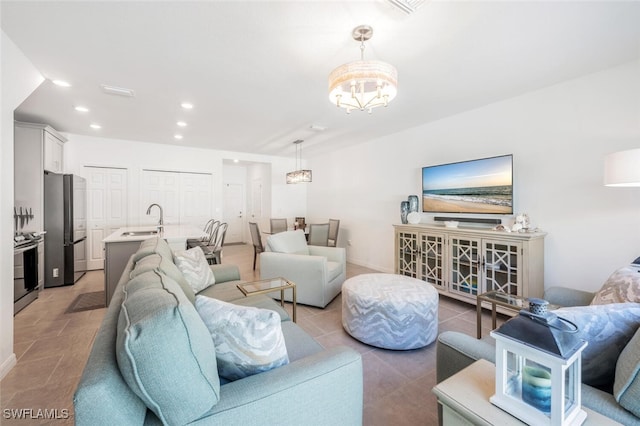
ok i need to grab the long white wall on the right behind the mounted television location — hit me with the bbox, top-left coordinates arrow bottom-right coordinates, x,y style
307,61 -> 640,290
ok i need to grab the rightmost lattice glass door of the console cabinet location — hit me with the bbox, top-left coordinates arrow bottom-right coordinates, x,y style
482,240 -> 523,296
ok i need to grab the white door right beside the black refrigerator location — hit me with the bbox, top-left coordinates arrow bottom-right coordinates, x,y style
84,167 -> 128,270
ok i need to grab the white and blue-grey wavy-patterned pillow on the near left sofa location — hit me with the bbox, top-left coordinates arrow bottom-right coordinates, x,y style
196,296 -> 289,380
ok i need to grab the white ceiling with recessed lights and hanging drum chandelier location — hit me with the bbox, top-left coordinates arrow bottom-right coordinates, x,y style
0,0 -> 640,157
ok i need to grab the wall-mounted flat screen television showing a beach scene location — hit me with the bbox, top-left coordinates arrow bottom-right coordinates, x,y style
422,154 -> 513,214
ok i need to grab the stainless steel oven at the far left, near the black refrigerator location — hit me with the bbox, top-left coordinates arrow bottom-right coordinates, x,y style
13,241 -> 38,315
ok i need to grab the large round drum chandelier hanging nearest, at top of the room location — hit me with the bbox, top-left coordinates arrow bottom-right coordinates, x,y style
329,25 -> 398,114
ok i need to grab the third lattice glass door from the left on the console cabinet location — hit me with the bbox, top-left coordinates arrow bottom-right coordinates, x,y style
449,235 -> 483,300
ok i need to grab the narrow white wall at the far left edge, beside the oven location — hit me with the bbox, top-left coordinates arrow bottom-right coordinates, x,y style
0,31 -> 44,379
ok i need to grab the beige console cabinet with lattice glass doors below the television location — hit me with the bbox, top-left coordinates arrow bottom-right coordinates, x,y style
394,224 -> 546,315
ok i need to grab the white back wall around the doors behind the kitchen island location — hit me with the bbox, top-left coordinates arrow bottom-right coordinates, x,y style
64,134 -> 306,230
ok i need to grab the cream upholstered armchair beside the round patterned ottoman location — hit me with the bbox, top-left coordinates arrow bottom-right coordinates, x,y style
260,230 -> 347,308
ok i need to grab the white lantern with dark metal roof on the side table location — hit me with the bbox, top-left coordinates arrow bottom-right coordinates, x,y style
490,299 -> 587,426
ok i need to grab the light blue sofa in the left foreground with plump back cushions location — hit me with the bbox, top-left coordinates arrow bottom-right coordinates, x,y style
74,239 -> 363,426
